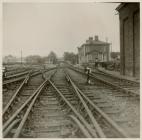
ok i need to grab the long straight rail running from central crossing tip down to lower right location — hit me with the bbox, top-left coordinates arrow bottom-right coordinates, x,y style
49,80 -> 97,137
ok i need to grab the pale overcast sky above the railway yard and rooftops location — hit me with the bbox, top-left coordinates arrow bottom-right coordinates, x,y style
2,3 -> 120,57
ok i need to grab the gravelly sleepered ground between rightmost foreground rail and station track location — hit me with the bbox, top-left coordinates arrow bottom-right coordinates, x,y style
68,69 -> 140,138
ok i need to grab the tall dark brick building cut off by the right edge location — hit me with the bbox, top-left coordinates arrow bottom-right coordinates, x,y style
116,3 -> 140,77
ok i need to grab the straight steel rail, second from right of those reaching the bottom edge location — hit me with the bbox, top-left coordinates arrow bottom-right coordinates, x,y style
66,73 -> 106,138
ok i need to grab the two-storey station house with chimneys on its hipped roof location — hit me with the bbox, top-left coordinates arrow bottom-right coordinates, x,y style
78,36 -> 110,64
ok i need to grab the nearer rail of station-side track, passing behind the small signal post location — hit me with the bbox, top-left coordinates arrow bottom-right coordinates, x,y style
70,67 -> 140,98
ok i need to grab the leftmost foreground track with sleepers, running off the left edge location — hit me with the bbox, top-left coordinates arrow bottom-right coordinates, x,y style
3,68 -> 57,135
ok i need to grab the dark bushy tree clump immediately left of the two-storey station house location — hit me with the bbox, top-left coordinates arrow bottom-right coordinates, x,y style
64,52 -> 78,64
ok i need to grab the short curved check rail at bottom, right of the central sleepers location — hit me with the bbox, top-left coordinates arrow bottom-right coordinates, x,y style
68,115 -> 92,138
